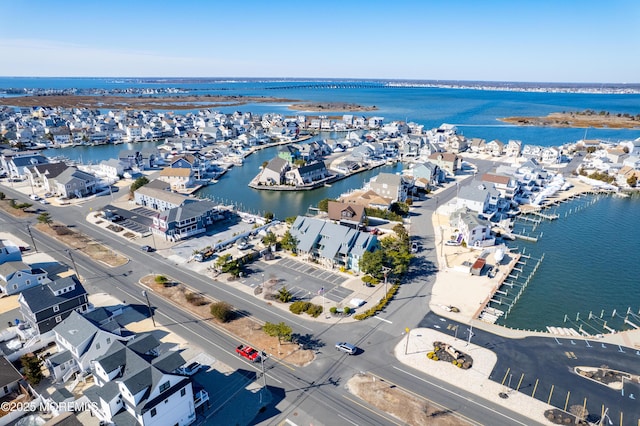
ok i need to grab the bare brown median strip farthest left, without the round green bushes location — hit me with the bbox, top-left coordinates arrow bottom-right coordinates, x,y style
35,223 -> 129,267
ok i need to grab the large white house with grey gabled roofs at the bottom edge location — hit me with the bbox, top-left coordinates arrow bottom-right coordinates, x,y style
84,337 -> 201,426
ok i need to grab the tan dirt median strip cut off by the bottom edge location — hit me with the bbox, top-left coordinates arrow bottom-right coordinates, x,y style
347,374 -> 471,426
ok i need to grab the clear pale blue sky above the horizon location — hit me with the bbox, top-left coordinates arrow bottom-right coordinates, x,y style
0,0 -> 640,83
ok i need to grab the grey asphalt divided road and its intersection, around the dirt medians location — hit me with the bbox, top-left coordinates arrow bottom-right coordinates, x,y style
0,184 -> 544,425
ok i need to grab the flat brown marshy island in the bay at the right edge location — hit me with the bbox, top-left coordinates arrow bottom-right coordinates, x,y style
499,110 -> 640,129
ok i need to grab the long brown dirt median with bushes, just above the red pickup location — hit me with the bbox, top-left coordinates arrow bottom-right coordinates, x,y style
140,275 -> 315,367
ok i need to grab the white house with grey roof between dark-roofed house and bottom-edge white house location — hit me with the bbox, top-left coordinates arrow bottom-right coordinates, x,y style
46,308 -> 133,383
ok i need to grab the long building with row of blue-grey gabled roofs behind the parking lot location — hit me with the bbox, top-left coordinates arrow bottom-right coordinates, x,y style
290,216 -> 378,273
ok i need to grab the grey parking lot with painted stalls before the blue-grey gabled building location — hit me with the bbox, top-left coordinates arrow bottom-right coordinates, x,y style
240,258 -> 354,303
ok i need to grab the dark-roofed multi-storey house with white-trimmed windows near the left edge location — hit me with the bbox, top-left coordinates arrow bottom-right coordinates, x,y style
18,275 -> 89,335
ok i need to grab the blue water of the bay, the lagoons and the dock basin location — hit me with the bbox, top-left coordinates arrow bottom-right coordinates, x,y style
0,77 -> 640,333
